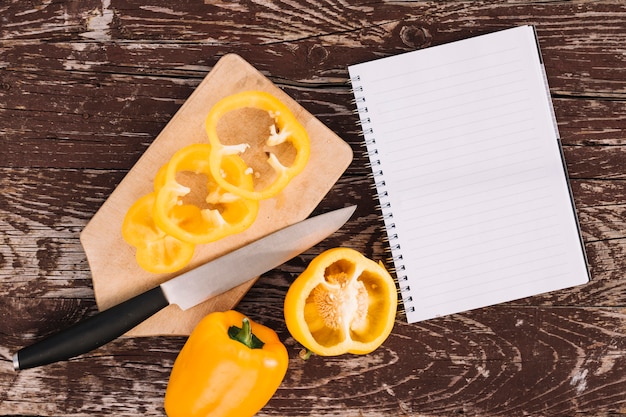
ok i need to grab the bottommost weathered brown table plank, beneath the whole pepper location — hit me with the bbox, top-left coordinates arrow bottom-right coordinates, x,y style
0,302 -> 626,416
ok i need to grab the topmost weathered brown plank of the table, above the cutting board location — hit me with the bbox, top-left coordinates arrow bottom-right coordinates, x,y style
0,0 -> 626,88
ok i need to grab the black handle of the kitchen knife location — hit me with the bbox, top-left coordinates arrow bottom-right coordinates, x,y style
13,287 -> 169,371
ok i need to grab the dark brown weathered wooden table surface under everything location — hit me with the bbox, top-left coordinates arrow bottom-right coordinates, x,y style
0,0 -> 626,417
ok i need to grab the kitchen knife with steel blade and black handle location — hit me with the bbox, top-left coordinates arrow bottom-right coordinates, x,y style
13,206 -> 356,370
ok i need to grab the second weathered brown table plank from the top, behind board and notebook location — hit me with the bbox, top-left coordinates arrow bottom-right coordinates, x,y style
0,69 -> 626,170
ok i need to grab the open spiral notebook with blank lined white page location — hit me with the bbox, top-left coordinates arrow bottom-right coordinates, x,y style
349,26 -> 590,322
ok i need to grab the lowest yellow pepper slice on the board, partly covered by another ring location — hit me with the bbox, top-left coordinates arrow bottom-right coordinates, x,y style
122,193 -> 195,273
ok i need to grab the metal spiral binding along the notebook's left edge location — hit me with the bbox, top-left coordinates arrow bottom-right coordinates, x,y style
350,75 -> 415,313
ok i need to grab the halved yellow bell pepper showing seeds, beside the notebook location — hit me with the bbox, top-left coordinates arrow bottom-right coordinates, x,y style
284,248 -> 398,356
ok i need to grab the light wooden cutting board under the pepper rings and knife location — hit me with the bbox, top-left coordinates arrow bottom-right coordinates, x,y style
80,54 -> 352,336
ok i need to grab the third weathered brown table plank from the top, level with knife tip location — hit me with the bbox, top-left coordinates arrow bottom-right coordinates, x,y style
0,169 -> 626,306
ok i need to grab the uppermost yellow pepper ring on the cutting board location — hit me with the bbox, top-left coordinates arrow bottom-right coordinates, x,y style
206,91 -> 310,200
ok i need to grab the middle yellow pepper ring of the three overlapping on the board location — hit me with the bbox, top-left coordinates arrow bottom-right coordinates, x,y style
154,143 -> 259,244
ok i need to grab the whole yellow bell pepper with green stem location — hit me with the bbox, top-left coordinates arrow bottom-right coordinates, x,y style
165,310 -> 289,417
